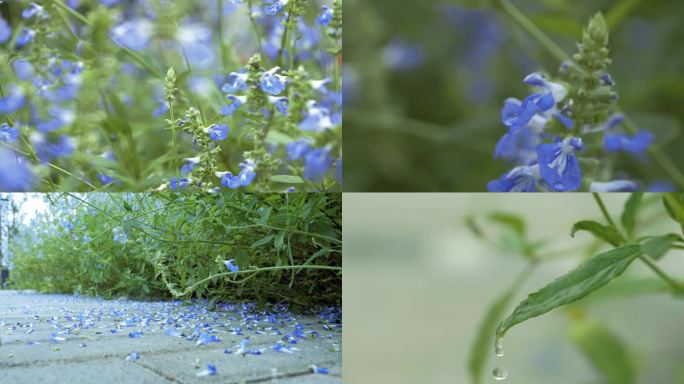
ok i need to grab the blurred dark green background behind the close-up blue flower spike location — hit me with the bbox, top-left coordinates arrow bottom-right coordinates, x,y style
344,0 -> 684,191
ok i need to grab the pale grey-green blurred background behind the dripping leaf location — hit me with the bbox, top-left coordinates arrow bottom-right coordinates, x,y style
343,193 -> 684,384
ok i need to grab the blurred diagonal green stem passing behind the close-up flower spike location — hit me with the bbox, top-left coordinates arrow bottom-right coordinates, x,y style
497,0 -> 684,189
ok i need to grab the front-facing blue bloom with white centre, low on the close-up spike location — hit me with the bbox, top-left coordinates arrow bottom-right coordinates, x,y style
537,137 -> 583,192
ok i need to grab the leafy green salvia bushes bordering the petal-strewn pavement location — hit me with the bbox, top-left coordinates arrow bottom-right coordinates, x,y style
9,192 -> 342,308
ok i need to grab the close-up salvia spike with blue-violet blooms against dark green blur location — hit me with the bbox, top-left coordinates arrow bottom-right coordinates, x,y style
487,9 -> 682,192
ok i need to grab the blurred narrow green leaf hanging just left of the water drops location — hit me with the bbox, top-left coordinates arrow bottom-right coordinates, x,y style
468,269 -> 529,384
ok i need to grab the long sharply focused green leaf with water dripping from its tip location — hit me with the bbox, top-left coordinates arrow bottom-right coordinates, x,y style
496,245 -> 641,337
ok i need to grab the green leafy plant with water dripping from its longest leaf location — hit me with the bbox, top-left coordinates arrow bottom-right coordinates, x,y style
466,192 -> 684,384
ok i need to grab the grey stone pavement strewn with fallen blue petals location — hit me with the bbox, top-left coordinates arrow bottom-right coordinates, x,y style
0,291 -> 342,384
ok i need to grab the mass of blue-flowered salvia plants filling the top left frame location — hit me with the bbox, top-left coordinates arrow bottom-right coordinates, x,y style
0,0 -> 342,191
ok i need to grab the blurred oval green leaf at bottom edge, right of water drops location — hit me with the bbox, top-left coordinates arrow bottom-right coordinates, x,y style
571,321 -> 635,384
